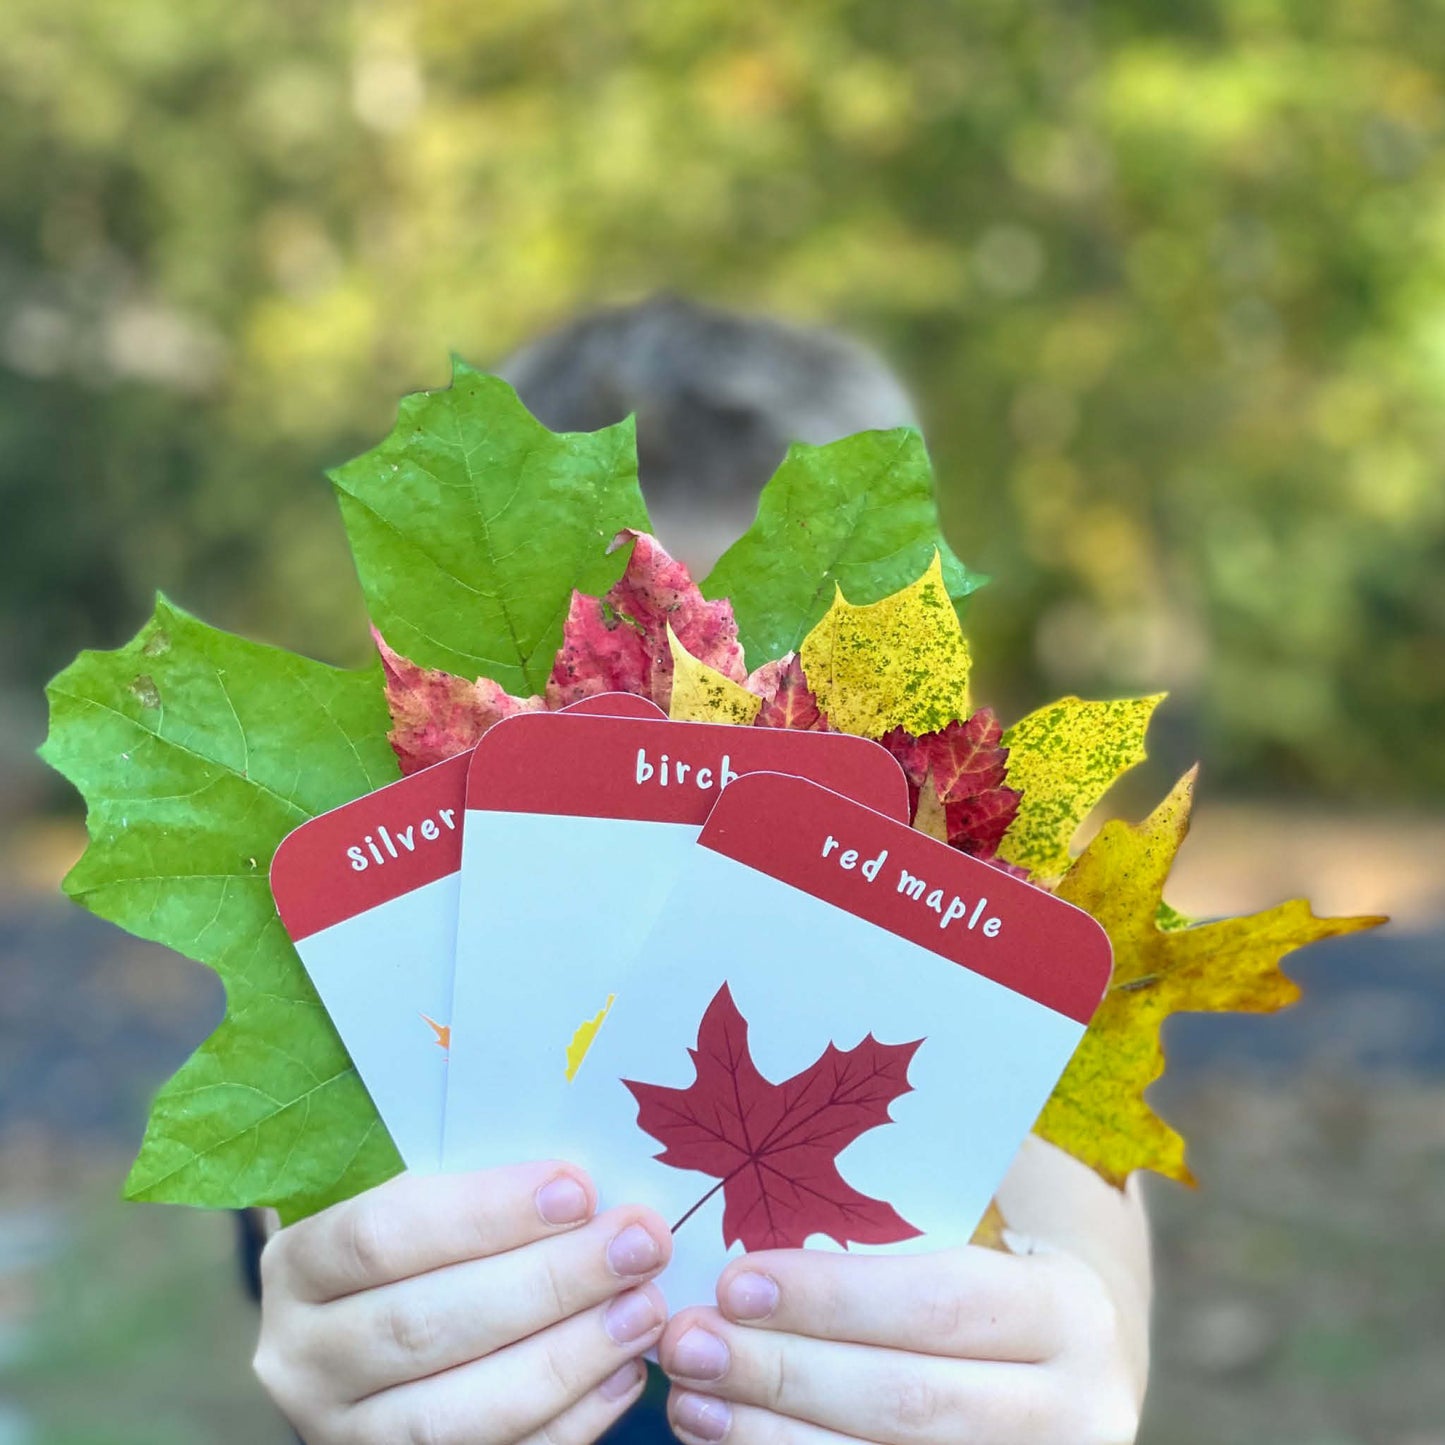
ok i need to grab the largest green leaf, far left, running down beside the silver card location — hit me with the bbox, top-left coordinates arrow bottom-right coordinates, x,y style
42,598 -> 400,1218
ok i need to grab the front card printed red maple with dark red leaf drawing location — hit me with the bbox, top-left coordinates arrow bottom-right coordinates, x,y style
548,773 -> 1111,1308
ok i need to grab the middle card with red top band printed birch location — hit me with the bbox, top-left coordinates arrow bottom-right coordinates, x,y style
445,714 -> 909,1169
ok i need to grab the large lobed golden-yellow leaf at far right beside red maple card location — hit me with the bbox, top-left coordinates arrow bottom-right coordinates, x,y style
1035,772 -> 1384,1188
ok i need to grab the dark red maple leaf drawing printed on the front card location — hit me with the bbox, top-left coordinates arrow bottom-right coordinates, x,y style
623,984 -> 923,1250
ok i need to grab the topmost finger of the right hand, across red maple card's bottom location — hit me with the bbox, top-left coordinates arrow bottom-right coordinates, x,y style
718,1248 -> 1077,1364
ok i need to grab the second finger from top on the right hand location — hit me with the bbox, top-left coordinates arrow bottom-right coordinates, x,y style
660,1311 -> 1053,1445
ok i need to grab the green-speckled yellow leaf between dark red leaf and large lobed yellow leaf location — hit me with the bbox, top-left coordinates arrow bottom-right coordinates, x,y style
998,692 -> 1165,879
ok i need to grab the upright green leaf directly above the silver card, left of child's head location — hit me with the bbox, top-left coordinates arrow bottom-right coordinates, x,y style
331,361 -> 647,694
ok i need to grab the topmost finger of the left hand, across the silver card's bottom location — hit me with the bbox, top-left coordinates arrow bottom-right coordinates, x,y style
271,1163 -> 597,1303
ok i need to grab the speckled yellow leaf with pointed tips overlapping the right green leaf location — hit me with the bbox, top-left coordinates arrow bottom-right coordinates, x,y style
799,552 -> 970,737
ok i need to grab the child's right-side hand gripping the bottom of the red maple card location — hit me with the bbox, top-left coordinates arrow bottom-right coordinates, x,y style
660,1248 -> 1139,1445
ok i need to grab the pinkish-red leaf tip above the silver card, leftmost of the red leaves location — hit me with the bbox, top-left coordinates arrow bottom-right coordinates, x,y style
371,627 -> 546,775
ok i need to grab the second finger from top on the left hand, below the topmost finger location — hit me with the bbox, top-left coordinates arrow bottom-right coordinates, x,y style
309,1205 -> 672,1400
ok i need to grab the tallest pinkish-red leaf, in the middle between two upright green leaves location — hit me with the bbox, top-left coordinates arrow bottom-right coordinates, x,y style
546,530 -> 747,709
